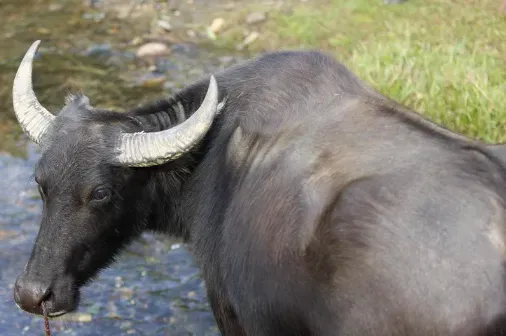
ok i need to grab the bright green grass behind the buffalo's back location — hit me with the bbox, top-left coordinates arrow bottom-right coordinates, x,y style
213,0 -> 506,142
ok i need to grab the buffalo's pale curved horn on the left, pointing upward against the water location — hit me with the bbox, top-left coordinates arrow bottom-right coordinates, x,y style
12,40 -> 55,144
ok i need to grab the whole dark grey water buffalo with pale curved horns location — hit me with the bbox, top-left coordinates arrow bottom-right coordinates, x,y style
13,41 -> 506,336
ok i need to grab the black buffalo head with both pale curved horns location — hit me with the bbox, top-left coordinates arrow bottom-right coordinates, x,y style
13,41 -> 218,316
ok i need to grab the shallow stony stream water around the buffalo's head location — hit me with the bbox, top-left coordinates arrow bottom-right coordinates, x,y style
0,0 -> 249,336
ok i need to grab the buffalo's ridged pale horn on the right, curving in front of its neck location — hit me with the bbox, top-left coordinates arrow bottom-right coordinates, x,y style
115,76 -> 218,167
